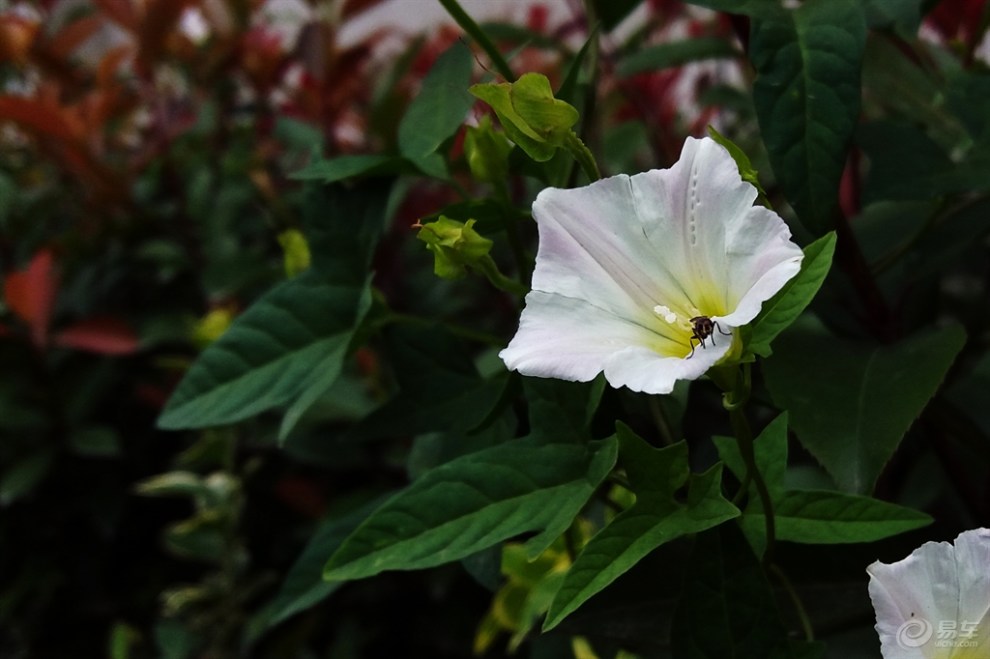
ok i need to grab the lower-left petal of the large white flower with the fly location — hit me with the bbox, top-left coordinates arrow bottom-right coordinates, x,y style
499,290 -> 680,386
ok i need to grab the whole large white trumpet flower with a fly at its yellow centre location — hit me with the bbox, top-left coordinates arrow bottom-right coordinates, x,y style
501,138 -> 803,394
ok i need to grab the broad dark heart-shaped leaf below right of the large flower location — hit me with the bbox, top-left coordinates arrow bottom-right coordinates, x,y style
764,319 -> 966,494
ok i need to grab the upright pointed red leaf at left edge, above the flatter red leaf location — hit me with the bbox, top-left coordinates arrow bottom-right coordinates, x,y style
3,249 -> 58,348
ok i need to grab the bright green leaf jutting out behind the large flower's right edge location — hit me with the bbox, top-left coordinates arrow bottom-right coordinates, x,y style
744,232 -> 835,357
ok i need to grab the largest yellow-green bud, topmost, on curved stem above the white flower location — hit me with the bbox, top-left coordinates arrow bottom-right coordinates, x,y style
468,73 -> 578,162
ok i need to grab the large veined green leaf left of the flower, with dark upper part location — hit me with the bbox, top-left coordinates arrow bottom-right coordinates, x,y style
158,183 -> 387,439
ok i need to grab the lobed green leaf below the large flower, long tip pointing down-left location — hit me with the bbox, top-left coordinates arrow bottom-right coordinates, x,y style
543,423 -> 739,631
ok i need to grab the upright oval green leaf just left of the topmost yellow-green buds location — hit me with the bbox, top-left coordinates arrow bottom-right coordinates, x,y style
398,41 -> 474,173
